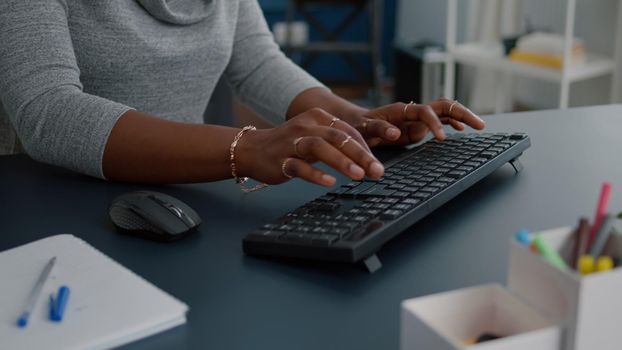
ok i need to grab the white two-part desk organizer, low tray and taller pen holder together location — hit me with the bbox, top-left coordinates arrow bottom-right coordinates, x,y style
400,228 -> 622,350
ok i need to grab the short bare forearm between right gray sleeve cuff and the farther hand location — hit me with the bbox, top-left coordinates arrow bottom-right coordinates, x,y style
287,88 -> 368,121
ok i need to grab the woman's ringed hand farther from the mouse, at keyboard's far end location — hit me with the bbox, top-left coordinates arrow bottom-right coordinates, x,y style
347,98 -> 485,146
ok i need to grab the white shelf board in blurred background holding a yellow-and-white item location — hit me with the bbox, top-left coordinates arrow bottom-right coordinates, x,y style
451,43 -> 615,83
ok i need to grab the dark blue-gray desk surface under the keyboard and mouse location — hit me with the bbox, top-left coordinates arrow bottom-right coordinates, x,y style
0,106 -> 622,349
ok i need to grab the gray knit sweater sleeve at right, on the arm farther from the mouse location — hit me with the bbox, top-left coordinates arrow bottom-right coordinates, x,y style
225,0 -> 332,123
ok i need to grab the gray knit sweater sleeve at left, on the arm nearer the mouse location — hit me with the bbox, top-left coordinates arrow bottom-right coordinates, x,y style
0,0 -> 131,178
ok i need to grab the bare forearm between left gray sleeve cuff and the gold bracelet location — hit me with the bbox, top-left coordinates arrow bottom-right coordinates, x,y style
103,111 -> 239,183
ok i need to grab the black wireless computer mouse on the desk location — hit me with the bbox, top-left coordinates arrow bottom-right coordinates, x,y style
108,191 -> 201,241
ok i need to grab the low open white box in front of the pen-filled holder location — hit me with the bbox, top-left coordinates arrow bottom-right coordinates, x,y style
400,284 -> 561,350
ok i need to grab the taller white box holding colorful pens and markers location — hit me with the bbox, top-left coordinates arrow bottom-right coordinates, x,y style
508,228 -> 622,350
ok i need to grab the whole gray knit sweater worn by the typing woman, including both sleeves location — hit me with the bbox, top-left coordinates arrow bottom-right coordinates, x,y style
0,0 -> 321,177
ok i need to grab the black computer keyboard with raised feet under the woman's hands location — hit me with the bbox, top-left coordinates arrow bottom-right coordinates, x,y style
243,133 -> 530,271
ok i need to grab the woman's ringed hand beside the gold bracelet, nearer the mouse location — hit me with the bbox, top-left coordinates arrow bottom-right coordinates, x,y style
235,108 -> 384,187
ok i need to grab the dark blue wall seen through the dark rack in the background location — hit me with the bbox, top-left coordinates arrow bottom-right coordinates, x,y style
259,0 -> 396,82
